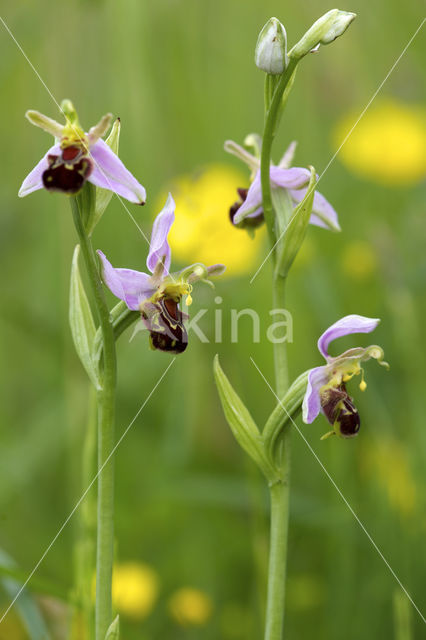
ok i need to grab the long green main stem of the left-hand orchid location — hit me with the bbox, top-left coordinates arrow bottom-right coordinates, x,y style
71,197 -> 116,640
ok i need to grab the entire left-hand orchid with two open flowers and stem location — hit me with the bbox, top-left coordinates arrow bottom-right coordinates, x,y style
19,100 -> 225,640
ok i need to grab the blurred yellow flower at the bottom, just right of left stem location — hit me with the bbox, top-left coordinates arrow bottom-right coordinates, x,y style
112,562 -> 159,620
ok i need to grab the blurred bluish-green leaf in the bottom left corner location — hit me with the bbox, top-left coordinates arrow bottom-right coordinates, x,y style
0,549 -> 50,640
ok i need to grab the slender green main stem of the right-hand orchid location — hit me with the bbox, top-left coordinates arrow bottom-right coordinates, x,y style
260,59 -> 297,640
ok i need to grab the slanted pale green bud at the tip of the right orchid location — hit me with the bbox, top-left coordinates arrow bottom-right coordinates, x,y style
289,9 -> 356,60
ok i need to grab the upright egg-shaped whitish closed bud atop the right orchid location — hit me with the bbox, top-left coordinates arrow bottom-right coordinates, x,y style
254,18 -> 288,75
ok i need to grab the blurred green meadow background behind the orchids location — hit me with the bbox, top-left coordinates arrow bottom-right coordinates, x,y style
0,0 -> 426,640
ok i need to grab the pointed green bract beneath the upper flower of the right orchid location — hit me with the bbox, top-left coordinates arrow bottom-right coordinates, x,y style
276,167 -> 317,278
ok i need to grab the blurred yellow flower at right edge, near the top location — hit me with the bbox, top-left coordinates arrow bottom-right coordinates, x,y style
333,99 -> 426,186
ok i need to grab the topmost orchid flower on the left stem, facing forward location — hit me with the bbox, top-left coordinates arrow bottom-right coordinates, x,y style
19,100 -> 146,204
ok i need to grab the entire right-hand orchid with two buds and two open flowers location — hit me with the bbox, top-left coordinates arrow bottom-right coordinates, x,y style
214,9 -> 388,640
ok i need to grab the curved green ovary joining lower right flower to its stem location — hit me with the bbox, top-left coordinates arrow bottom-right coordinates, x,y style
262,371 -> 309,466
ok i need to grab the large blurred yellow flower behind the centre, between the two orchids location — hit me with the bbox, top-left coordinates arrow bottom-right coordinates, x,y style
156,165 -> 264,277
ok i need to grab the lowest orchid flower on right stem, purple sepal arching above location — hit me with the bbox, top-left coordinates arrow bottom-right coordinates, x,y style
303,315 -> 389,439
